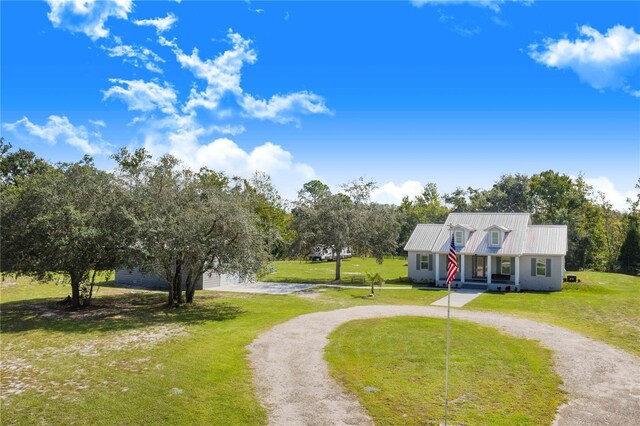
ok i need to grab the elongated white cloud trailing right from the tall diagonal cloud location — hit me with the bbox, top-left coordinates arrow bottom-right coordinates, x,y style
240,92 -> 331,123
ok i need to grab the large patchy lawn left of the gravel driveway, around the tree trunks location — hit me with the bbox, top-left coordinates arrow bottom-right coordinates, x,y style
0,279 -> 441,425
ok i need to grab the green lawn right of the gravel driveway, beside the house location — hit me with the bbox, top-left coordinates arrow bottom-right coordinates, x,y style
464,272 -> 640,356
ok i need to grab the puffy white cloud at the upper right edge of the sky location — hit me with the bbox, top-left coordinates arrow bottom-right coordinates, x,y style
529,25 -> 640,97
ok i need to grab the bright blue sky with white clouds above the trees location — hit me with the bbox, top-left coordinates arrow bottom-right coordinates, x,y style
0,0 -> 640,208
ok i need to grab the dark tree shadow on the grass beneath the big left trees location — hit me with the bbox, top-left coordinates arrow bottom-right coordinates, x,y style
0,292 -> 244,333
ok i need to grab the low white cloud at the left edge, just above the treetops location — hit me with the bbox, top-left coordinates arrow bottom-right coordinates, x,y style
4,115 -> 105,155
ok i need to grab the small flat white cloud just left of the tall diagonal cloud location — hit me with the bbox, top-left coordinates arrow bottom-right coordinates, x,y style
103,78 -> 177,114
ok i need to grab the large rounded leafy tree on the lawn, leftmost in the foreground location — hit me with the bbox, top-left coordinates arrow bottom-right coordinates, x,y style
0,156 -> 133,308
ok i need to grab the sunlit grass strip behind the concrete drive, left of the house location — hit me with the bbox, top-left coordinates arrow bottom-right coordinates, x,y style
260,257 -> 409,284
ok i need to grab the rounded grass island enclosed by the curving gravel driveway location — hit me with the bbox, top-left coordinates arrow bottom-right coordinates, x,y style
325,317 -> 564,425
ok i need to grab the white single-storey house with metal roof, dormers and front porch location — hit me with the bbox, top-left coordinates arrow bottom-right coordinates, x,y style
404,213 -> 567,291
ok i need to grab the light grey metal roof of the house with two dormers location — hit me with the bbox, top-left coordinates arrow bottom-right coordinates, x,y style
405,213 -> 567,256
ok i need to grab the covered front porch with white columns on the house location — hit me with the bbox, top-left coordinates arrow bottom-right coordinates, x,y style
434,253 -> 520,291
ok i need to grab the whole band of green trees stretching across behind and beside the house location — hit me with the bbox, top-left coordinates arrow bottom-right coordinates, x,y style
0,138 -> 640,307
